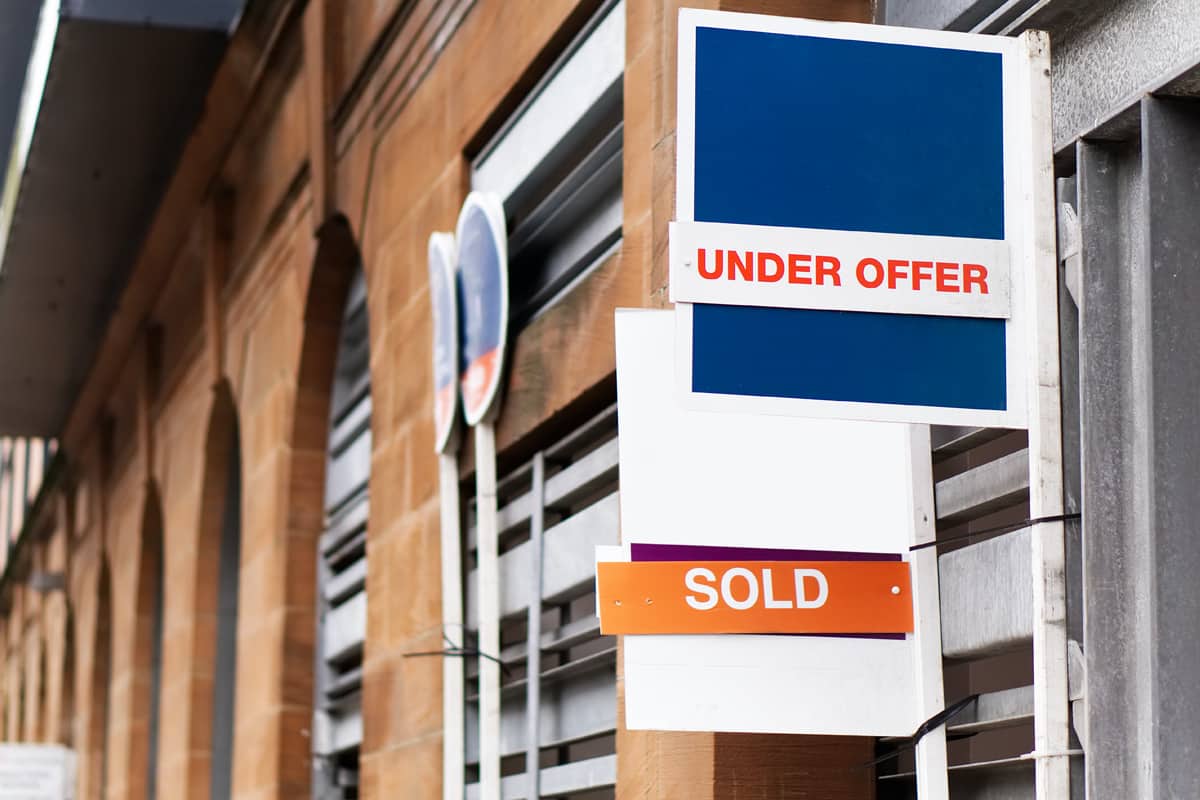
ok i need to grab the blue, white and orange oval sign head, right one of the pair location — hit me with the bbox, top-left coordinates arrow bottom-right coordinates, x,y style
456,192 -> 509,425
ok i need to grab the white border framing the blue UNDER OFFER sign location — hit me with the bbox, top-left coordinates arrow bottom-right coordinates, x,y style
672,8 -> 1056,428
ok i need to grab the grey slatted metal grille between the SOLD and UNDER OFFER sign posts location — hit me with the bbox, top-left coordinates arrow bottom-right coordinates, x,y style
878,426 -> 1034,800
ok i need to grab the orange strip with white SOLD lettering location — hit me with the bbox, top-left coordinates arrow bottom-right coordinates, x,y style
596,561 -> 913,634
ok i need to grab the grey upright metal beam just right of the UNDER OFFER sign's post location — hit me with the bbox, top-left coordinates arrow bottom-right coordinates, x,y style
1076,136 -> 1151,800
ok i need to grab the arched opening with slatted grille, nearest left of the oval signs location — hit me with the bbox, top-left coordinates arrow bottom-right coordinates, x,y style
313,271 -> 371,800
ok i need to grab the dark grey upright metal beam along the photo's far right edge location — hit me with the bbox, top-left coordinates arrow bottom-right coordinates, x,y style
1141,96 -> 1200,798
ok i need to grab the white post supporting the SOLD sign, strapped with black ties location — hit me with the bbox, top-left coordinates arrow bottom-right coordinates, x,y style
908,425 -> 950,800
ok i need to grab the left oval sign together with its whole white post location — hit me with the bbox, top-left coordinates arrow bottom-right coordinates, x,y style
428,233 -> 466,800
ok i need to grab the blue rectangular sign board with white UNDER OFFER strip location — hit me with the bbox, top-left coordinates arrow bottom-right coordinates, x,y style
672,11 -> 1032,425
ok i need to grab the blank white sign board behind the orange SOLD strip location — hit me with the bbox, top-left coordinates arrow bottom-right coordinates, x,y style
614,311 -> 942,735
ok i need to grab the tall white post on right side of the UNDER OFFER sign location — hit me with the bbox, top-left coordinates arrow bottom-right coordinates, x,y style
1021,31 -> 1070,800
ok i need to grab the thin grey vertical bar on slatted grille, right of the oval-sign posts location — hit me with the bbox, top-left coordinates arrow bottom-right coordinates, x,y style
526,452 -> 546,800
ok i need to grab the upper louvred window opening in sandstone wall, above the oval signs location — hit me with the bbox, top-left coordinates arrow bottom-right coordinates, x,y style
472,0 -> 625,326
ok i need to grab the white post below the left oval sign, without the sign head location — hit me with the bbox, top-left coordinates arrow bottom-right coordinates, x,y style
438,453 -> 466,800
